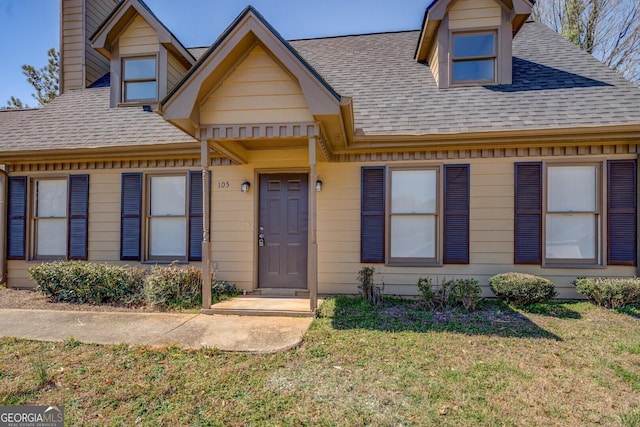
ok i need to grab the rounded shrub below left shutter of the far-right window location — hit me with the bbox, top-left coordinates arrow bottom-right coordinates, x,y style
489,273 -> 557,305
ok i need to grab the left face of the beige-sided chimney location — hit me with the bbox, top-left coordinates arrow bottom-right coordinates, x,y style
60,0 -> 85,92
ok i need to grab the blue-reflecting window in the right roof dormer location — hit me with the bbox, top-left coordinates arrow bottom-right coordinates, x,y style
451,31 -> 496,83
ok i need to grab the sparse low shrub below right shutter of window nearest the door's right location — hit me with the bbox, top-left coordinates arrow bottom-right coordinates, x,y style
418,277 -> 482,311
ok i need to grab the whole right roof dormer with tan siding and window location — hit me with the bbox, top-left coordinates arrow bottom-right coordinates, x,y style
416,0 -> 532,89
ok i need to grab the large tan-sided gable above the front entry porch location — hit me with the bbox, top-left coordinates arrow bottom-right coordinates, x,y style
161,6 -> 351,144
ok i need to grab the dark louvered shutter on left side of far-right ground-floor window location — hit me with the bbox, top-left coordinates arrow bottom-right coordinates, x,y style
513,162 -> 542,264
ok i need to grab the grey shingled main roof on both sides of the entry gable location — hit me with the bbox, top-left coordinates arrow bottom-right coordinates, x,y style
0,19 -> 640,157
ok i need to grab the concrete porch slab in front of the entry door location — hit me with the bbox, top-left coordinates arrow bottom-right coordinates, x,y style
201,295 -> 322,317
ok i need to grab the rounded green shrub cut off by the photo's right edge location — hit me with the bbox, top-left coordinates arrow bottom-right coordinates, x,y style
574,277 -> 640,309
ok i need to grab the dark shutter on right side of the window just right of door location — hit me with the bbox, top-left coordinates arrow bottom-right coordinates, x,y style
443,165 -> 470,264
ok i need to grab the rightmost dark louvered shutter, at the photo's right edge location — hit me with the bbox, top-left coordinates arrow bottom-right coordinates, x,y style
607,160 -> 637,265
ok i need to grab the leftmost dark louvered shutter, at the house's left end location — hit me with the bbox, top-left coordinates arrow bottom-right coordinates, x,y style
7,176 -> 27,259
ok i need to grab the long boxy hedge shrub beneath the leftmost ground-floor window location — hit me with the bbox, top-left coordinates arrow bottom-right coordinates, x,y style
29,261 -> 147,304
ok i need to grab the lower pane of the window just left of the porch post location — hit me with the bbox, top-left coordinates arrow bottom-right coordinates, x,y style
149,218 -> 187,258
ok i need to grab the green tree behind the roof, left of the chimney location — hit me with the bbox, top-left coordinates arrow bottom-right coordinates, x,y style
4,48 -> 60,109
